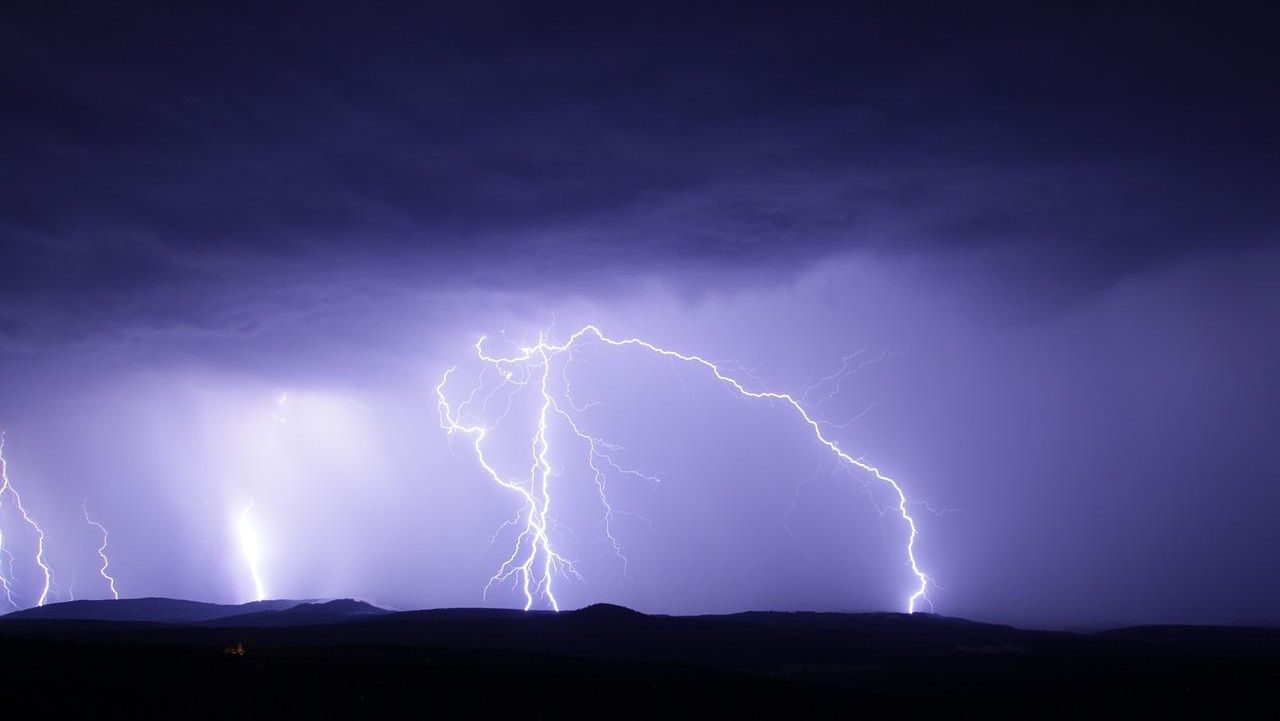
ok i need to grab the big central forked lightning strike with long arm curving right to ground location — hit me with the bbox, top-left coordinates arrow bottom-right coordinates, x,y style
435,325 -> 929,613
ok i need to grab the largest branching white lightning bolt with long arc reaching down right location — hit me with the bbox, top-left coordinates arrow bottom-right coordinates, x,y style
445,325 -> 929,613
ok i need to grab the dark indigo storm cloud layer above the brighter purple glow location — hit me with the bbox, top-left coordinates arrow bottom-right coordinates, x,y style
0,3 -> 1280,335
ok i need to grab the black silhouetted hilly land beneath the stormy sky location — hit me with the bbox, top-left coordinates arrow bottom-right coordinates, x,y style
0,599 -> 1280,718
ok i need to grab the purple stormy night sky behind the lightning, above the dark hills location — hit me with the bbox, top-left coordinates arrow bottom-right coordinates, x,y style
0,1 -> 1280,626
